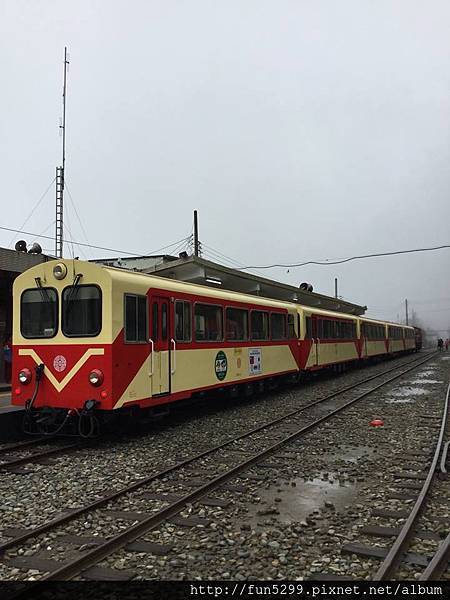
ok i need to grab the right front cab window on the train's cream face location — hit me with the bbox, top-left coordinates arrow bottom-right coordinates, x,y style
61,285 -> 102,337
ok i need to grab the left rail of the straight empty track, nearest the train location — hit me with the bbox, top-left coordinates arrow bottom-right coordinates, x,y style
0,352 -> 436,555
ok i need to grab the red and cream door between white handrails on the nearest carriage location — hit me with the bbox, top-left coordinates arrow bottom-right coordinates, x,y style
150,296 -> 171,396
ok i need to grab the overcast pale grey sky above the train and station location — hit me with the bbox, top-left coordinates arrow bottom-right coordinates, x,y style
0,0 -> 450,329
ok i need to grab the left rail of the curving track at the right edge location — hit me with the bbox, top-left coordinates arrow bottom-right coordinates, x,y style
373,384 -> 450,581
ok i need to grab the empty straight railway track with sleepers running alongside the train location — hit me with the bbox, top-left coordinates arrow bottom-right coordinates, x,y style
0,353 -> 435,581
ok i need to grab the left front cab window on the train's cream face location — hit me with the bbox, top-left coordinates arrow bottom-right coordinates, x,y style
20,287 -> 58,338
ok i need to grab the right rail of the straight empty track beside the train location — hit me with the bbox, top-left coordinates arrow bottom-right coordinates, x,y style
38,358 -> 440,583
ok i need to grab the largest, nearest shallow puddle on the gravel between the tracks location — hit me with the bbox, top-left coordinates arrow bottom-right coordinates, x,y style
247,478 -> 357,527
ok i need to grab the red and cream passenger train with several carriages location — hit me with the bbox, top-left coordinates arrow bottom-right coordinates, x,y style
12,260 -> 416,436
